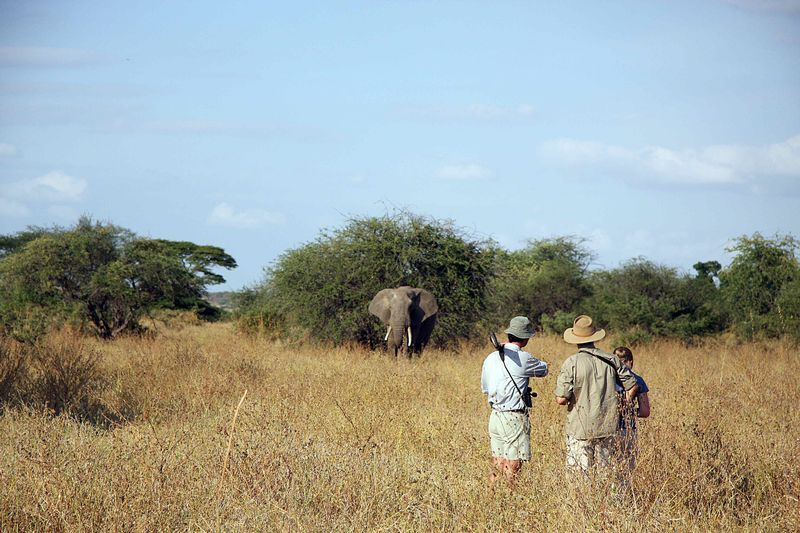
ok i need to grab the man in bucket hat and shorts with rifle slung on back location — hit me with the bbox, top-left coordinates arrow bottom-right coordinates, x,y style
481,316 -> 548,488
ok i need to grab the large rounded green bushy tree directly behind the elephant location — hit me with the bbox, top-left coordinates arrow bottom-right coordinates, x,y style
240,213 -> 494,346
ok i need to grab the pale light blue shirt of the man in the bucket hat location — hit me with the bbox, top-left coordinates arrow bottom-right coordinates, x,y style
481,343 -> 547,411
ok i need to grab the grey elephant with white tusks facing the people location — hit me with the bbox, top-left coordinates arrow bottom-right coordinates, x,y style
369,286 -> 439,357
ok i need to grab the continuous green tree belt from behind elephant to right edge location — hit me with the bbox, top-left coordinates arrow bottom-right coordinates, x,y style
238,213 -> 800,347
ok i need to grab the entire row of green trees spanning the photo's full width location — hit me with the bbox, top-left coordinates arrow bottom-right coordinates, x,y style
0,213 -> 800,347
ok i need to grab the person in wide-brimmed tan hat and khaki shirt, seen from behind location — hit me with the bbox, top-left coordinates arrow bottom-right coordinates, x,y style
555,315 -> 638,474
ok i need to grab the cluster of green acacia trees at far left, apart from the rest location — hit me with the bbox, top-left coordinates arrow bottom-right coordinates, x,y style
0,217 -> 236,342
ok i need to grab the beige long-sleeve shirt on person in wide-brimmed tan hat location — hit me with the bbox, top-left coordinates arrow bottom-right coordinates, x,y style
555,348 -> 636,440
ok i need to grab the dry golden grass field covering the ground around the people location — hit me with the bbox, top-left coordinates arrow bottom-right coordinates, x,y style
0,325 -> 800,531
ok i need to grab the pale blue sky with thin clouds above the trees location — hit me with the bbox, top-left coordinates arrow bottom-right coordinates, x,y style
0,0 -> 800,289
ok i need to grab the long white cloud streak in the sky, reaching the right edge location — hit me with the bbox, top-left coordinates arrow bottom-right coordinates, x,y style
539,135 -> 800,185
